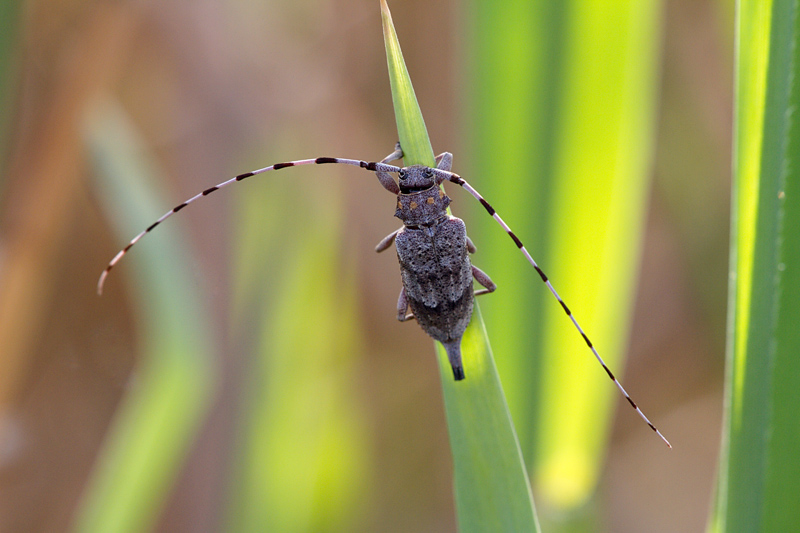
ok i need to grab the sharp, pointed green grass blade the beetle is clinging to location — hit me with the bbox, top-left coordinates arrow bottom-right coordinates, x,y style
381,0 -> 538,531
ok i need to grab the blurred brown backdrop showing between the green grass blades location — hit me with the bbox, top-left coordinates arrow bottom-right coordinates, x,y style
0,0 -> 733,532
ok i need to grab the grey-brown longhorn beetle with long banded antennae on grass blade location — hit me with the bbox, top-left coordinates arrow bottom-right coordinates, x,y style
97,143 -> 672,448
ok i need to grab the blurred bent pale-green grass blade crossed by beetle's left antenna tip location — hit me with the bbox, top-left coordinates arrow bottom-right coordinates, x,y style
75,100 -> 213,533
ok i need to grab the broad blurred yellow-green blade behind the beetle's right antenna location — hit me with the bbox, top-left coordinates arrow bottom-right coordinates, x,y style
468,0 -> 661,520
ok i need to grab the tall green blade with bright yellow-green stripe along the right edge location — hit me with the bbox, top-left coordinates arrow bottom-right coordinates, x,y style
710,0 -> 800,532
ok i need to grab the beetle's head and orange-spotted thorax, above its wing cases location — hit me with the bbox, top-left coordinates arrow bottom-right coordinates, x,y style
394,165 -> 450,226
